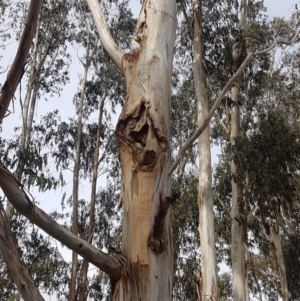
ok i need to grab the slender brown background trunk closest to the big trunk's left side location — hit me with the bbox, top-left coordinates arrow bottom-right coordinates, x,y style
79,94 -> 105,301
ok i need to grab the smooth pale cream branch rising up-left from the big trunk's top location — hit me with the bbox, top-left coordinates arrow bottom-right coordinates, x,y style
86,0 -> 124,70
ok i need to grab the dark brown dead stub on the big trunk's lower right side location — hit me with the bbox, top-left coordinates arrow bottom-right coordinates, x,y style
148,193 -> 180,254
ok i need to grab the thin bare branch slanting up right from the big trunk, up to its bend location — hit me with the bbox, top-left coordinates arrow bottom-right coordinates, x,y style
168,51 -> 255,176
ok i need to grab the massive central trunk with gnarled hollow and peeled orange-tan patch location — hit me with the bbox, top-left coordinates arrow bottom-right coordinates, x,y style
113,0 -> 176,301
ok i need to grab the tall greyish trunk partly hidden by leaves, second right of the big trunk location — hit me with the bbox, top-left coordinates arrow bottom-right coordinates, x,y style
230,0 -> 247,301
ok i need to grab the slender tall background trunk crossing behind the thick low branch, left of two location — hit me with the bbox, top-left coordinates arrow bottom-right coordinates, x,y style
69,29 -> 91,301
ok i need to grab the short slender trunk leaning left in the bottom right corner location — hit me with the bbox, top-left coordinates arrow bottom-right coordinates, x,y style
270,217 -> 289,301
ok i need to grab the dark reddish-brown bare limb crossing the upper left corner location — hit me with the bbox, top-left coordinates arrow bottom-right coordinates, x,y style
0,0 -> 43,123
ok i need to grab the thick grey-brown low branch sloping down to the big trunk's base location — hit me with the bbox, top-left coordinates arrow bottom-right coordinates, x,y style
0,165 -> 124,280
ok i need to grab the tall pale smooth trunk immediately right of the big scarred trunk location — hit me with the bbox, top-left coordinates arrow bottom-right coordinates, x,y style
193,0 -> 218,301
